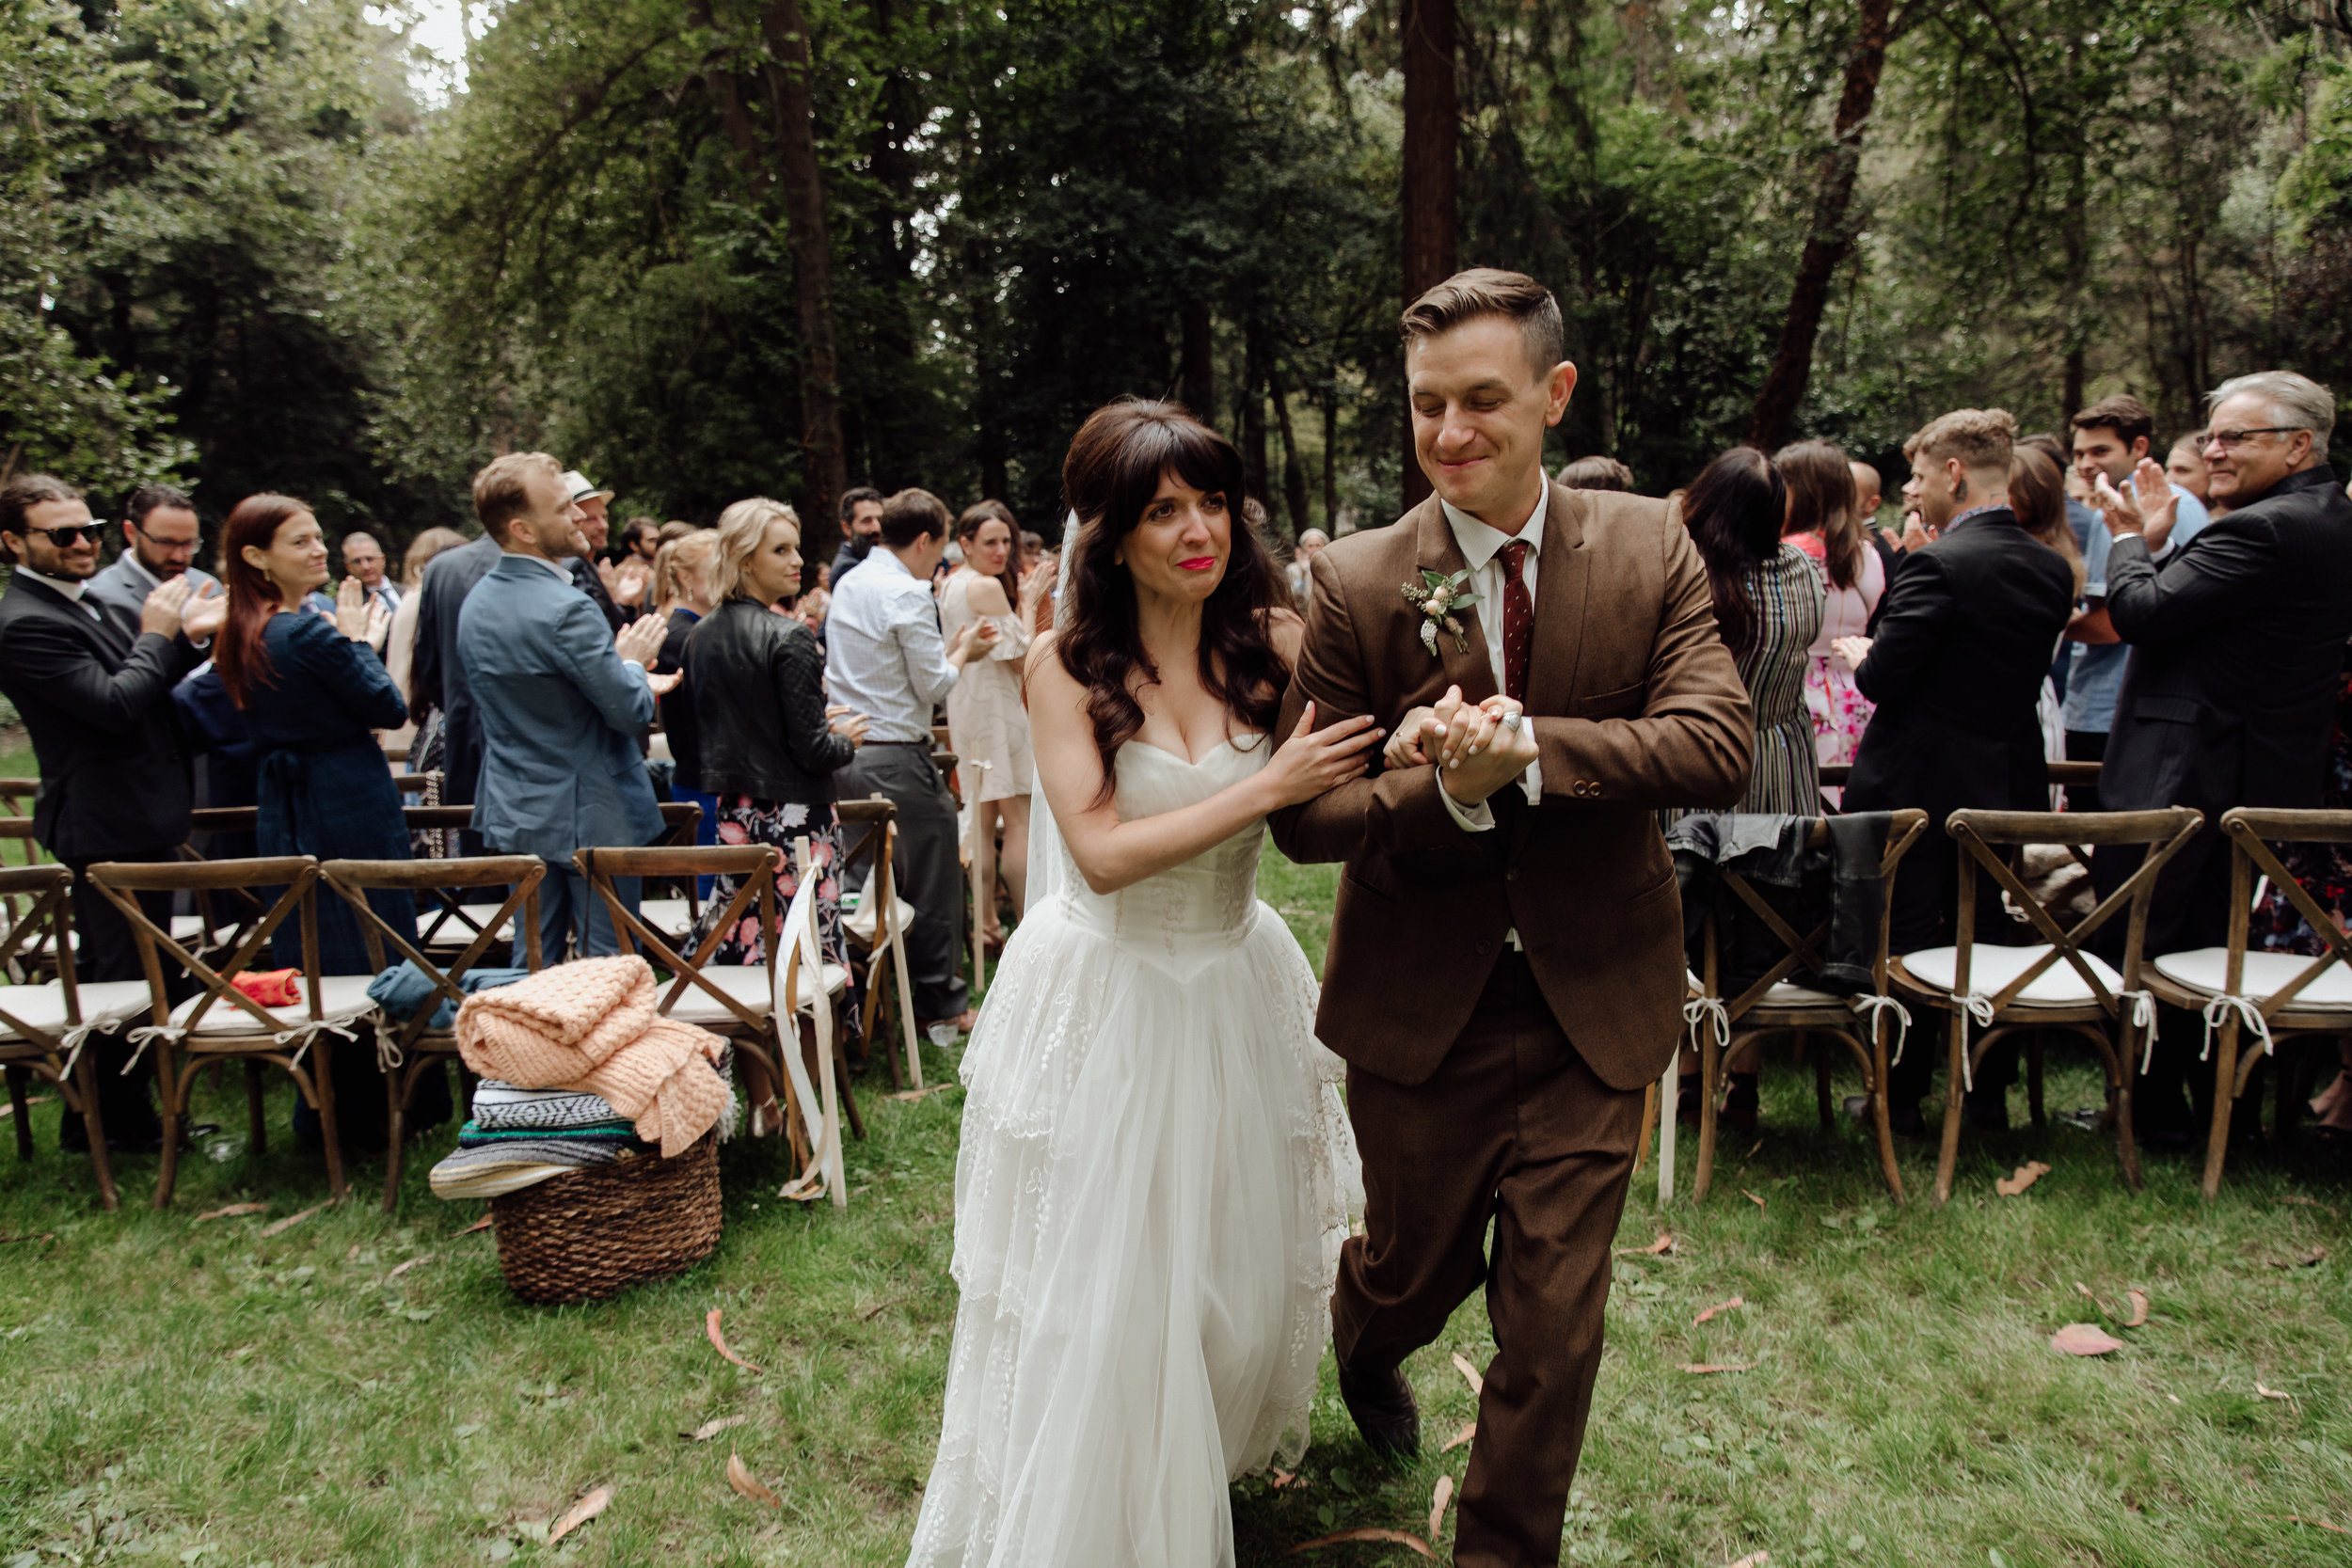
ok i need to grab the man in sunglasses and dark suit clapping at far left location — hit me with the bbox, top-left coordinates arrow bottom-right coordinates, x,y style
0,475 -> 229,1149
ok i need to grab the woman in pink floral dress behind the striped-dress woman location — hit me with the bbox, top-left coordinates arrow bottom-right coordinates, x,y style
1773,442 -> 1886,800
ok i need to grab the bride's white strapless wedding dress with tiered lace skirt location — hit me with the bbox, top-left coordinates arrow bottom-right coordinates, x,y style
911,736 -> 1362,1568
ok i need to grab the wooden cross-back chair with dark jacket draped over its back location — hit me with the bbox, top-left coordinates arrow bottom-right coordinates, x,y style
1659,809 -> 1927,1204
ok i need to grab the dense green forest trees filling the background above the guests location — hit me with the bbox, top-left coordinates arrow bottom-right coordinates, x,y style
0,0 -> 2352,562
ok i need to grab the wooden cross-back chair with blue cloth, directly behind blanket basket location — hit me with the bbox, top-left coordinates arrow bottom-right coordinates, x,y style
320,856 -> 548,1213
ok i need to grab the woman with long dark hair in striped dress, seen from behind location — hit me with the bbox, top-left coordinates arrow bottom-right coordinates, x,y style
1682,447 -> 1828,816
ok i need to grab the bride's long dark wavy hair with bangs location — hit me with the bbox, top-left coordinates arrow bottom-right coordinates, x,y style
1054,397 -> 1289,800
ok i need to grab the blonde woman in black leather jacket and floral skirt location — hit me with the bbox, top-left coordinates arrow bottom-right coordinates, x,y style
680,496 -> 866,1006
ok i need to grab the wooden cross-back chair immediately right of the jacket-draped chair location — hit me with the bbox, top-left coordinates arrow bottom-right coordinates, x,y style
1891,806 -> 2204,1206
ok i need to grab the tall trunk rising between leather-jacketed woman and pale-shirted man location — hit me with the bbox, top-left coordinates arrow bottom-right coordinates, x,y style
762,0 -> 850,560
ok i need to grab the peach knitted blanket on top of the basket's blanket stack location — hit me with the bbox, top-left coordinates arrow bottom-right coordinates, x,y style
456,955 -> 727,1157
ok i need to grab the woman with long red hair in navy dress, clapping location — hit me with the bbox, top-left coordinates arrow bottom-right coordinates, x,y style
212,496 -> 423,1149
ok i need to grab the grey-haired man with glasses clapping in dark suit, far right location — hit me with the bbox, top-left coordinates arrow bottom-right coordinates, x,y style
2093,372 -> 2352,1148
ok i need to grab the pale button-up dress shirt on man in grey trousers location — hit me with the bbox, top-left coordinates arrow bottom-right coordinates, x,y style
826,546 -> 955,745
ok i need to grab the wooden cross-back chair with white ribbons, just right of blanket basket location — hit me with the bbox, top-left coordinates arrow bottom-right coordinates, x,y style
572,844 -> 866,1165
